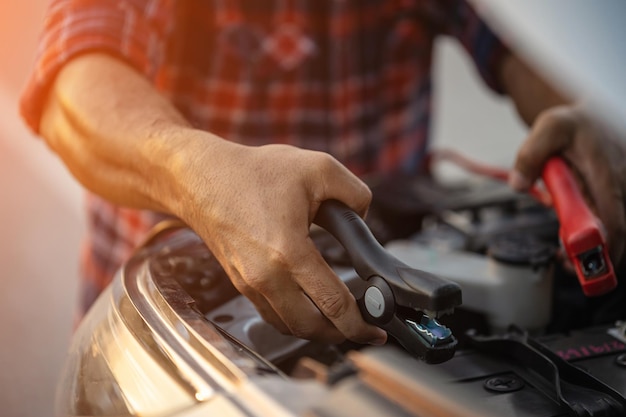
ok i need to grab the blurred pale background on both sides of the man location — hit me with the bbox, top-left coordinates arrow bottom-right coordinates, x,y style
0,0 -> 525,417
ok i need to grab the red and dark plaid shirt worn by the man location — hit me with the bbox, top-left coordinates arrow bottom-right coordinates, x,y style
21,0 -> 504,310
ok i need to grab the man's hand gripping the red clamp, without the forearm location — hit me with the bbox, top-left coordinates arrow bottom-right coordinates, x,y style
509,105 -> 626,266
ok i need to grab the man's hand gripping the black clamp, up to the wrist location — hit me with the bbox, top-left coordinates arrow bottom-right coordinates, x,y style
180,141 -> 386,344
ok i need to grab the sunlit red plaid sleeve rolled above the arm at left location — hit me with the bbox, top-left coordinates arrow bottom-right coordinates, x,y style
20,0 -> 173,133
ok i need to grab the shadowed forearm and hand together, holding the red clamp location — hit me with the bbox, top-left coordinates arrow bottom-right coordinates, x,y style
500,54 -> 626,266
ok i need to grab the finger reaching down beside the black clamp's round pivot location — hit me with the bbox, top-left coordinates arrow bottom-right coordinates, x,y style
294,239 -> 387,344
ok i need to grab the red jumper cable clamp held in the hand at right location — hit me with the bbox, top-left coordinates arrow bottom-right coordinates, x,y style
542,157 -> 617,297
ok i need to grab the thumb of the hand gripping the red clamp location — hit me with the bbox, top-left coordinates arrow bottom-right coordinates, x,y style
508,107 -> 575,191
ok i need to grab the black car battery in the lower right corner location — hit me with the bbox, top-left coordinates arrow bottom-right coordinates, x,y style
448,327 -> 626,416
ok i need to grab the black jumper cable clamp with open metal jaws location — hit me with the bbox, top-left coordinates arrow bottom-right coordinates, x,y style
314,200 -> 461,363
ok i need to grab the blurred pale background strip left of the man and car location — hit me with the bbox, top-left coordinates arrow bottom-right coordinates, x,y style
0,0 -> 84,417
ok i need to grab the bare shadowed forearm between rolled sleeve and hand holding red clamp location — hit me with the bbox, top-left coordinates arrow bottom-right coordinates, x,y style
499,53 -> 571,126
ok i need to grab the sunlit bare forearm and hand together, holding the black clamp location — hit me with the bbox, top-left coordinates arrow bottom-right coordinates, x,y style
41,55 -> 386,343
